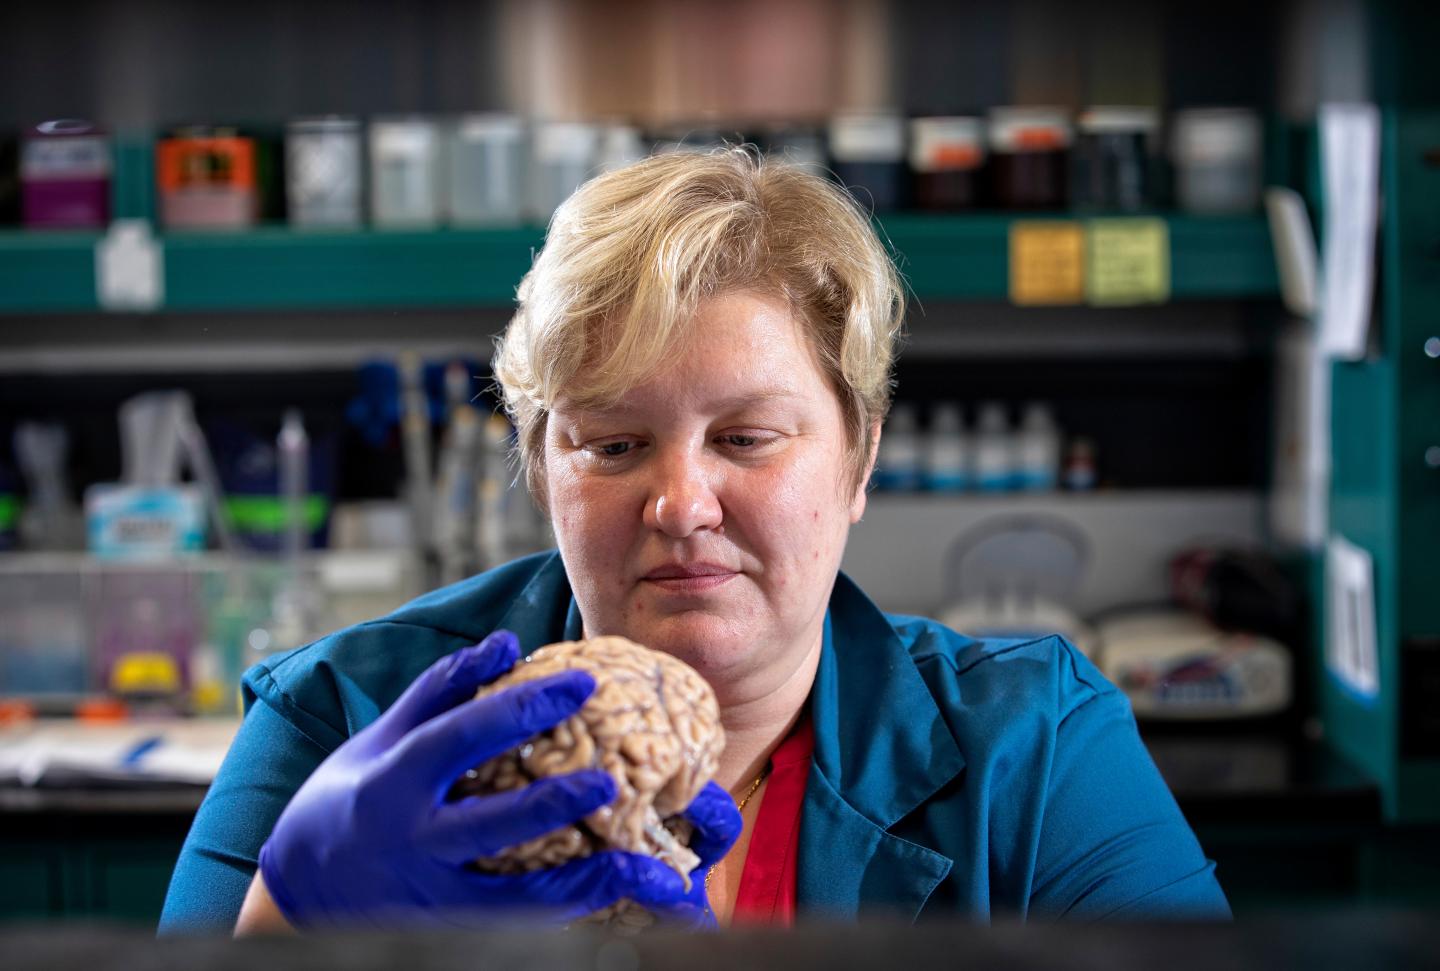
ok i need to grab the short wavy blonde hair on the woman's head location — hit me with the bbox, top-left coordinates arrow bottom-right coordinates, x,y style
492,148 -> 904,506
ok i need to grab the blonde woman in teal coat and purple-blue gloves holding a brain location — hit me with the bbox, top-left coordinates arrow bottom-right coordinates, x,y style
163,151 -> 1228,931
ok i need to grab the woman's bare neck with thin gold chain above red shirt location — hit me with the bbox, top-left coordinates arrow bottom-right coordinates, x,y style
716,635 -> 824,797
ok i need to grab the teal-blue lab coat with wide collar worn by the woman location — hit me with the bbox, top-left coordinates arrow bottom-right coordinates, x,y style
160,553 -> 1230,934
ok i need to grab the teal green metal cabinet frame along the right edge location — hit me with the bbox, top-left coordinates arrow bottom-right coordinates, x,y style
1316,109 -> 1440,823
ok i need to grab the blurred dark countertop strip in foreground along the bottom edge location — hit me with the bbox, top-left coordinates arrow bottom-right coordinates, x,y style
0,910 -> 1440,971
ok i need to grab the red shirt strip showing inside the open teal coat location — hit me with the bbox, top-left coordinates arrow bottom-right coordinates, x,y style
732,713 -> 815,928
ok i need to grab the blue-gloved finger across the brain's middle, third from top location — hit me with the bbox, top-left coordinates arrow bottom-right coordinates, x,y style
422,769 -> 615,863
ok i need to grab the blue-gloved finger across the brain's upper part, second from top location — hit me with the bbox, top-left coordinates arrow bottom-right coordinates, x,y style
387,671 -> 595,804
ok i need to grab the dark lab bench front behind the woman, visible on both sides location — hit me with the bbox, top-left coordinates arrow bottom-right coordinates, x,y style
0,723 -> 1440,925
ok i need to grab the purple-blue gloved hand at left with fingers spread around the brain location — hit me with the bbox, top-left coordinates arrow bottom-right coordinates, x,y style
259,631 -> 685,928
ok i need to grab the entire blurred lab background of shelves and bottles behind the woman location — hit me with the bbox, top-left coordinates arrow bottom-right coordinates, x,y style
0,0 -> 1440,923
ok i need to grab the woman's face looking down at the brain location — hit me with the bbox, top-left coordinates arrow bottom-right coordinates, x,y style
544,292 -> 865,703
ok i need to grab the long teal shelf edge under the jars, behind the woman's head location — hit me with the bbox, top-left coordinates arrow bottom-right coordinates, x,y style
0,213 -> 1279,314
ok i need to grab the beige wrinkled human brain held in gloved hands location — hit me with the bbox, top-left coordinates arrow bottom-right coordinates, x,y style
455,637 -> 724,919
